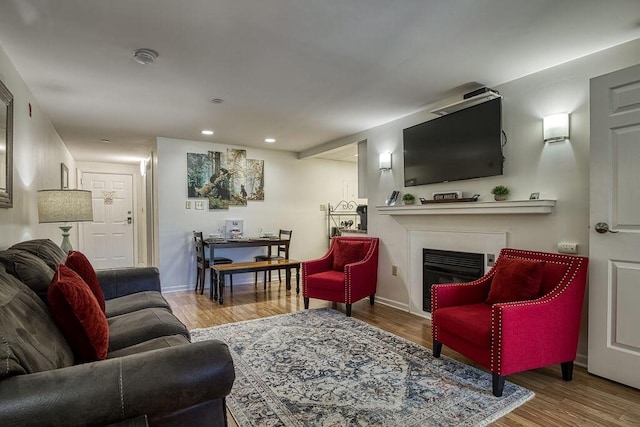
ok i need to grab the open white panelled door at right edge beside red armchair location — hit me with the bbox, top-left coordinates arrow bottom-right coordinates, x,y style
588,65 -> 640,388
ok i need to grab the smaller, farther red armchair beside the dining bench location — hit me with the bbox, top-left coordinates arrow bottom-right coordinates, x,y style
302,237 -> 378,316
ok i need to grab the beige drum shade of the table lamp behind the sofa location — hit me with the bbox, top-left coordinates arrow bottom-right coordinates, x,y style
38,190 -> 93,223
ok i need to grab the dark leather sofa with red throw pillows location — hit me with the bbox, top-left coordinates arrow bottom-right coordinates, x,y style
0,240 -> 235,426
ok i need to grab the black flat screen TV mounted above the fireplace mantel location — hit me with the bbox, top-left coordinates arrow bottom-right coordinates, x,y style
403,98 -> 503,187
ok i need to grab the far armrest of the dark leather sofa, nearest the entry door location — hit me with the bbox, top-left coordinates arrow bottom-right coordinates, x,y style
96,267 -> 161,299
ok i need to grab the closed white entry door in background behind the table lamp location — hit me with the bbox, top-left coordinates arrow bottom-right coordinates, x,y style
82,173 -> 133,269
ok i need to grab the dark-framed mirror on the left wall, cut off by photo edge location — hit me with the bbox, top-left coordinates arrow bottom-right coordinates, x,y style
0,82 -> 13,208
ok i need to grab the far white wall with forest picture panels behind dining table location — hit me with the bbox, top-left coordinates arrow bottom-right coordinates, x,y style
157,138 -> 358,291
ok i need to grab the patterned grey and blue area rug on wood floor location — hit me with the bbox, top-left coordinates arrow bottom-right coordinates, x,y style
191,308 -> 534,427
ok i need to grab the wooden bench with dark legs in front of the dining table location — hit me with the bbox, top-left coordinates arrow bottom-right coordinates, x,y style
209,259 -> 300,304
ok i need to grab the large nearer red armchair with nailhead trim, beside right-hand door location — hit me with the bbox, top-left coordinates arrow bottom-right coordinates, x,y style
431,248 -> 588,397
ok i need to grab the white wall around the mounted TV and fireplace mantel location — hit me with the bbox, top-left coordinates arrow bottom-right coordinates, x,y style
324,40 -> 640,357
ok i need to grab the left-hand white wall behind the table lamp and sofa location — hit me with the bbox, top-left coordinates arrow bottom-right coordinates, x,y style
0,43 -> 78,249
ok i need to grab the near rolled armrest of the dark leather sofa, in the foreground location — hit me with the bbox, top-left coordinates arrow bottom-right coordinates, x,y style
0,340 -> 235,426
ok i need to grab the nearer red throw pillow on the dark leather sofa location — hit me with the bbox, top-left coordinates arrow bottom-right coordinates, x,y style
47,264 -> 109,362
